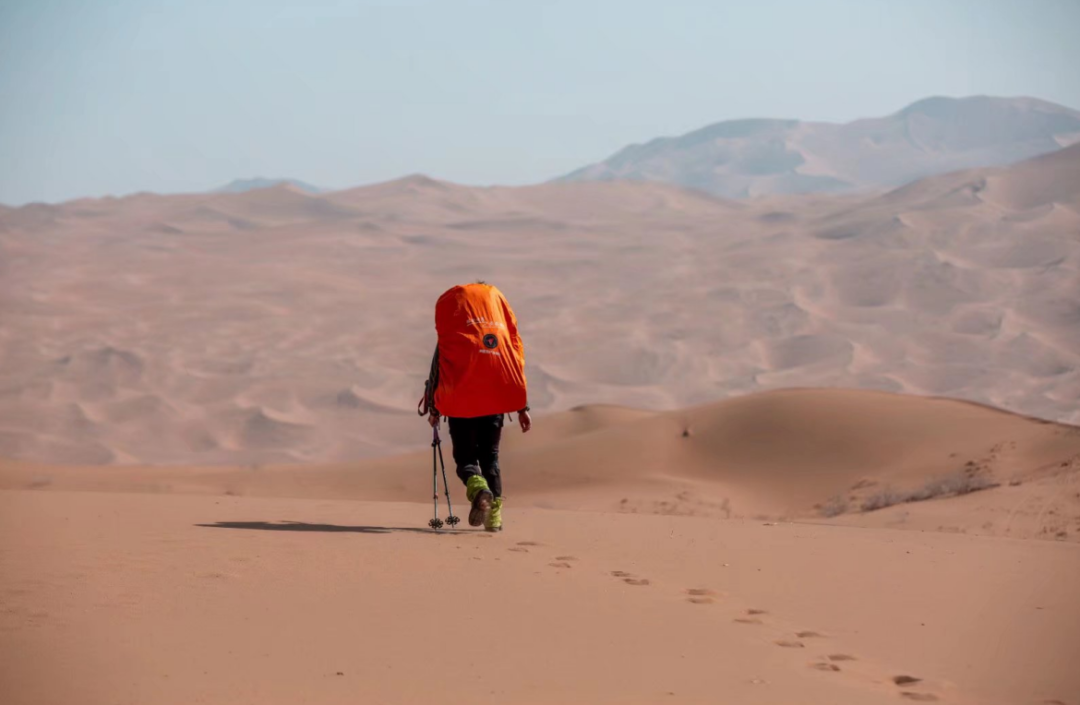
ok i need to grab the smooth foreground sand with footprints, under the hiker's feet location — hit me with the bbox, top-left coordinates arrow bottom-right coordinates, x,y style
0,490 -> 1080,705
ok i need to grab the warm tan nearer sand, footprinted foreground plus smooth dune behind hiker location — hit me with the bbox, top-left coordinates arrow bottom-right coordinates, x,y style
0,390 -> 1080,705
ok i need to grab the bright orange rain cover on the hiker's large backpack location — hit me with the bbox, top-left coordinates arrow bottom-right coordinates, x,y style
434,284 -> 528,419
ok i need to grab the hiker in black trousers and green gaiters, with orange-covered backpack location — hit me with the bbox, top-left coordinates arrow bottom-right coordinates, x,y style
421,281 -> 532,531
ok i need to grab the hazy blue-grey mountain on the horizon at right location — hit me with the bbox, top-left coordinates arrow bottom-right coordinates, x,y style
561,96 -> 1080,198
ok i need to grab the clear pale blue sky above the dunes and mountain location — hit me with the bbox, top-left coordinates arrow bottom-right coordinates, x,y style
0,0 -> 1080,204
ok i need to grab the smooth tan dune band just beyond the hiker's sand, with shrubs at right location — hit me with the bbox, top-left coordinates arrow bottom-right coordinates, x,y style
0,390 -> 1080,541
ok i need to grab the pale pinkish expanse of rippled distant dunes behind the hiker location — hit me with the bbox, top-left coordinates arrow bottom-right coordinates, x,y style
0,101 -> 1080,464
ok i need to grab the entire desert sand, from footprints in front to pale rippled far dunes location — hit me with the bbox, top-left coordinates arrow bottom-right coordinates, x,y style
0,120 -> 1080,705
